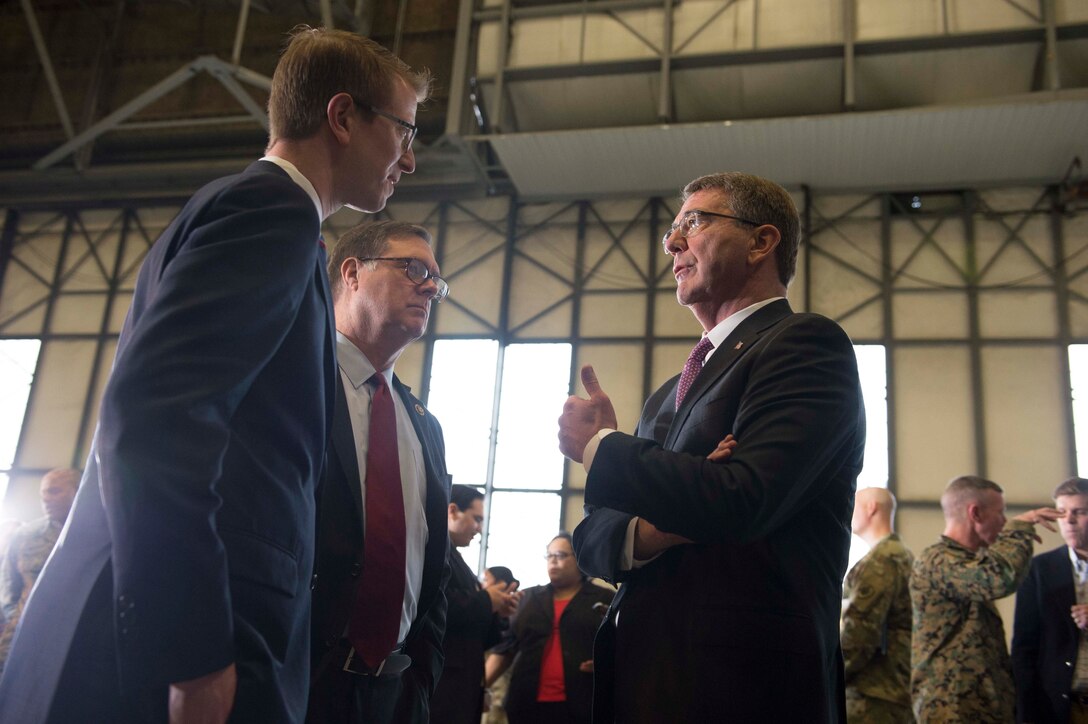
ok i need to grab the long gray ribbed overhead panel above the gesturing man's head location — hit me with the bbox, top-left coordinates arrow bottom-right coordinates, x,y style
491,91 -> 1088,198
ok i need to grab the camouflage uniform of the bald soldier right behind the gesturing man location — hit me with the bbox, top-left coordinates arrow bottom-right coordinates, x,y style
840,533 -> 914,724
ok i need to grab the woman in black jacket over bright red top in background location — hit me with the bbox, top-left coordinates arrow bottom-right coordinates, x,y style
486,532 -> 615,724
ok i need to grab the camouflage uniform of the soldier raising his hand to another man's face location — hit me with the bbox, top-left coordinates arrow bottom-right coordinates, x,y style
911,520 -> 1034,724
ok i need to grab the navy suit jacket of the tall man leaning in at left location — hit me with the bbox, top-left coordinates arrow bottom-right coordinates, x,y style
0,161 -> 336,722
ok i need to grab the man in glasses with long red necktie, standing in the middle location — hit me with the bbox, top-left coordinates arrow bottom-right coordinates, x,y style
307,221 -> 449,724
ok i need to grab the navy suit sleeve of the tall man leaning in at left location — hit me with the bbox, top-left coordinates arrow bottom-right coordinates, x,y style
98,173 -> 320,682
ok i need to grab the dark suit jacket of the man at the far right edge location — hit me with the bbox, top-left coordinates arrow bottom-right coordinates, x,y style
1012,545 -> 1080,724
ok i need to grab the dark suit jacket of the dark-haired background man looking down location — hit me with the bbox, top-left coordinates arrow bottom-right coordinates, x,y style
431,545 -> 506,724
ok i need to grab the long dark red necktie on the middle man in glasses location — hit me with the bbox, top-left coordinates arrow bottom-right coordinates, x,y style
347,372 -> 407,668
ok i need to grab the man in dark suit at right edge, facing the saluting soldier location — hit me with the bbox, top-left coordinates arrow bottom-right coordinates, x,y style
1012,478 -> 1088,724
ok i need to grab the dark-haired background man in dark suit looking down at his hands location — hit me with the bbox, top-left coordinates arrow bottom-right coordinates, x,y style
431,486 -> 518,724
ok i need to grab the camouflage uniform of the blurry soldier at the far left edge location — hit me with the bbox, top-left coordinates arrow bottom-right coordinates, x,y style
0,517 -> 61,672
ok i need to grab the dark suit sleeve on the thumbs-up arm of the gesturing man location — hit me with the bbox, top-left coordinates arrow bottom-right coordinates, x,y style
585,315 -> 861,543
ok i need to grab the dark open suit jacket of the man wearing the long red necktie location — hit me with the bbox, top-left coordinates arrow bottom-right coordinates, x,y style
310,375 -> 449,722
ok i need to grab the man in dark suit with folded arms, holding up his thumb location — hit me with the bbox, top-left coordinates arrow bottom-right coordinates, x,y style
559,173 -> 865,723
